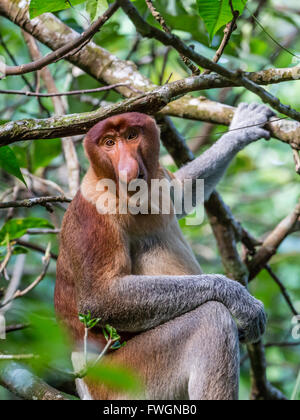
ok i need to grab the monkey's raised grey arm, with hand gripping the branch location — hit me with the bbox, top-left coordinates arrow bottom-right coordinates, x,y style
175,103 -> 275,200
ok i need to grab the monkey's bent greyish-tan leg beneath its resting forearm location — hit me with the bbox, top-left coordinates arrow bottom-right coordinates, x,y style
89,302 -> 239,400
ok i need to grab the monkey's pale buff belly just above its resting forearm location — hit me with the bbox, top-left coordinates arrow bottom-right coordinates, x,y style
130,223 -> 202,276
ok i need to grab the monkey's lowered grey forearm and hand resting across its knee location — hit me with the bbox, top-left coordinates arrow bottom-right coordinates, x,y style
79,275 -> 266,342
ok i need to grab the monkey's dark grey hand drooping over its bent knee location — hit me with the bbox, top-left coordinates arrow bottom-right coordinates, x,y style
219,279 -> 267,343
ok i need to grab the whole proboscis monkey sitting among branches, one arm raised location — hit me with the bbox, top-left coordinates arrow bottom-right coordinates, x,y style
55,104 -> 274,400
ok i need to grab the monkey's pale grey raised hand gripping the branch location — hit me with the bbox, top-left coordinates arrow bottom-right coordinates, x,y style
228,103 -> 276,148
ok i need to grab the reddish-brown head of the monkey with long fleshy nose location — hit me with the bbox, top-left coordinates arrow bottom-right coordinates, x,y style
84,112 -> 160,183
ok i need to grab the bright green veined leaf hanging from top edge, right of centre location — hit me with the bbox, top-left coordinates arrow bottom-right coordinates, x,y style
197,0 -> 246,40
